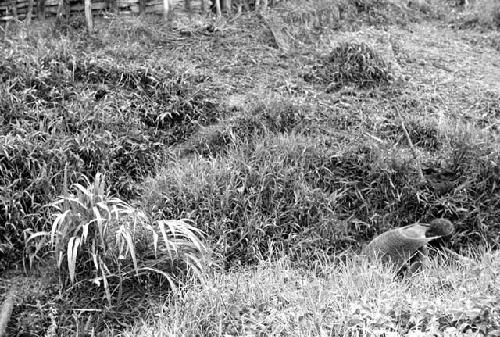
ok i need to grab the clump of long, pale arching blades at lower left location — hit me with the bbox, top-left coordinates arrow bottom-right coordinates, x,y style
27,174 -> 207,305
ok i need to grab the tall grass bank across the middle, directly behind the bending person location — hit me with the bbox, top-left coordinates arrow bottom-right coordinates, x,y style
143,114 -> 500,265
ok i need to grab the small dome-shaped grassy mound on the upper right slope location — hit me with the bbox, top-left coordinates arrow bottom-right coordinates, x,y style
304,42 -> 394,90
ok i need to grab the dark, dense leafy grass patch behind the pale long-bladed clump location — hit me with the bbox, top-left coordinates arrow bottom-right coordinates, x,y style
0,17 -> 223,267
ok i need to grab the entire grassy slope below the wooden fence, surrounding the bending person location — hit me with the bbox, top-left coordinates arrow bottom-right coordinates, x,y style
0,0 -> 500,335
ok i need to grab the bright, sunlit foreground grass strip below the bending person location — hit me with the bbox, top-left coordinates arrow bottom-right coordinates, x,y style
124,252 -> 500,336
